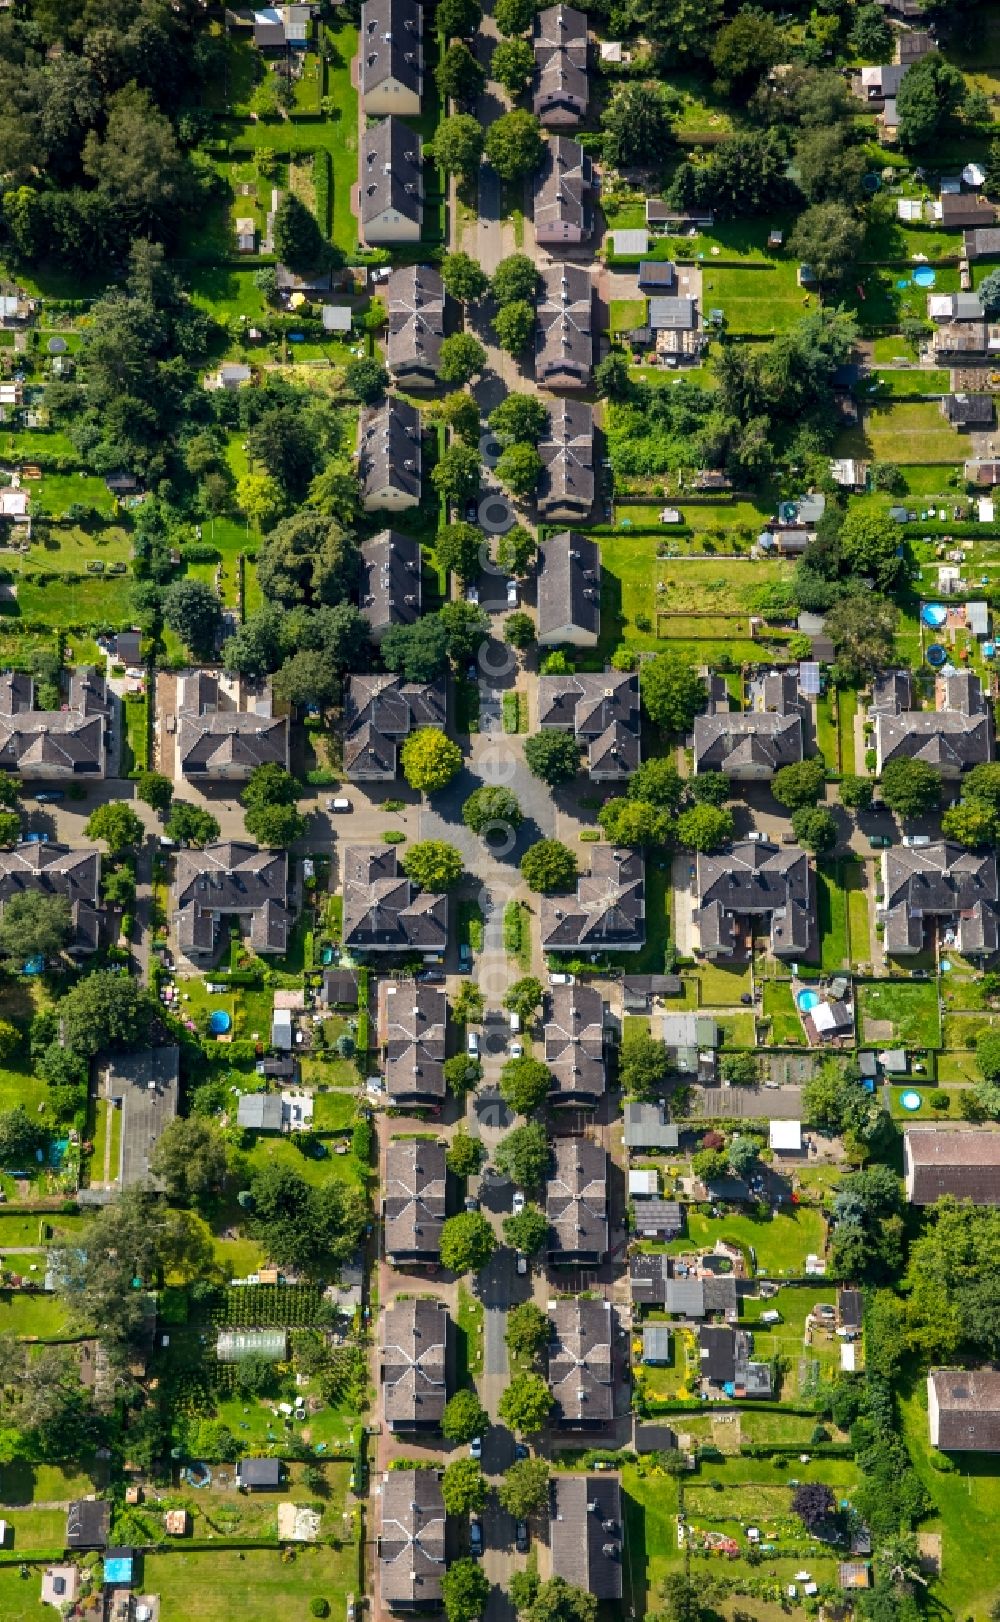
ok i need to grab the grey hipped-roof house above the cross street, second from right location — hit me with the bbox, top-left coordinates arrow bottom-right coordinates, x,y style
694,670 -> 804,782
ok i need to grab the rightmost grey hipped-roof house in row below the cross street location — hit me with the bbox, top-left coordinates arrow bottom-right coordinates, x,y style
882,839 -> 1000,957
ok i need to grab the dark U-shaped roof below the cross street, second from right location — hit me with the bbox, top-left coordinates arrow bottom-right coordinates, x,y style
695,839 -> 815,957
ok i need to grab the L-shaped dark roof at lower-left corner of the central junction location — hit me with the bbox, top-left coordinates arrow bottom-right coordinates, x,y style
342,845 -> 447,952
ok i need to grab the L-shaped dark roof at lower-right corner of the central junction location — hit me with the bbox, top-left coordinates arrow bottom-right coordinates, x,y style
541,845 -> 645,952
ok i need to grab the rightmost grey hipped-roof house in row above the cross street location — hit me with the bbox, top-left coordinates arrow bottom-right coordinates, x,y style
869,670 -> 994,777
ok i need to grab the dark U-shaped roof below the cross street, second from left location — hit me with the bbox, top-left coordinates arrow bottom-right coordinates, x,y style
173,840 -> 292,954
